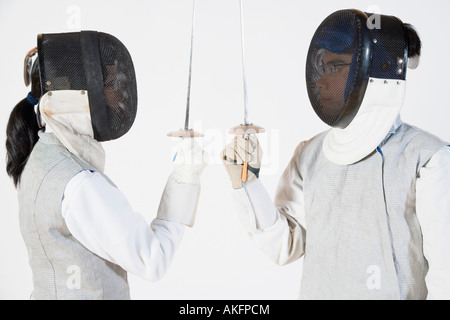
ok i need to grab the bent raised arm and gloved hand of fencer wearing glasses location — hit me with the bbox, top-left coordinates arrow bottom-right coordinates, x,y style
222,136 -> 305,265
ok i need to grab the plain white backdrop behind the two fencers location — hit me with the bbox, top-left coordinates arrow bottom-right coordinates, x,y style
0,0 -> 450,299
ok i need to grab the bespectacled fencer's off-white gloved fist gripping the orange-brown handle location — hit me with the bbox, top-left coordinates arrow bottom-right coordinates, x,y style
222,135 -> 262,189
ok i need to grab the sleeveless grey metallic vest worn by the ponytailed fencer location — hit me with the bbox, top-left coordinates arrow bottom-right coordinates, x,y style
18,132 -> 130,299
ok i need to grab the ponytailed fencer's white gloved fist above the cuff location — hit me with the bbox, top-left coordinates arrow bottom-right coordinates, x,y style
171,138 -> 208,186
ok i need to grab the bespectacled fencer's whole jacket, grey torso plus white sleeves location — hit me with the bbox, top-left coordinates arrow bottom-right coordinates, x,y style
233,120 -> 450,299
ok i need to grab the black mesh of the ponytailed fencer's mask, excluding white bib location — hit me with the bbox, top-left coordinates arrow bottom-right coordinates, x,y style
38,31 -> 137,141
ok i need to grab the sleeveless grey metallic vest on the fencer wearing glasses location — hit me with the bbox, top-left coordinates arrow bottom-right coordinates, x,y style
299,124 -> 446,299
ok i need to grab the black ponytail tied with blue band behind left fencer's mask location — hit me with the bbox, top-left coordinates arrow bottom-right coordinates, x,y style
6,60 -> 41,187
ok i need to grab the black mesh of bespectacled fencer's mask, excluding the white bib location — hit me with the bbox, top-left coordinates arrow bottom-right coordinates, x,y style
306,10 -> 407,128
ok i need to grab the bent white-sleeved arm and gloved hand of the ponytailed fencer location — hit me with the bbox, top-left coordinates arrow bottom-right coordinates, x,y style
62,139 -> 205,281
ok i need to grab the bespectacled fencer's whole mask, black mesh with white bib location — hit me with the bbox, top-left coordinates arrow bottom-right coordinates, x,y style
306,10 -> 408,165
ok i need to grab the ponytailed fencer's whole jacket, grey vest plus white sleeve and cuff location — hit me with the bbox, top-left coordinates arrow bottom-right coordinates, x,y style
18,132 -> 200,299
